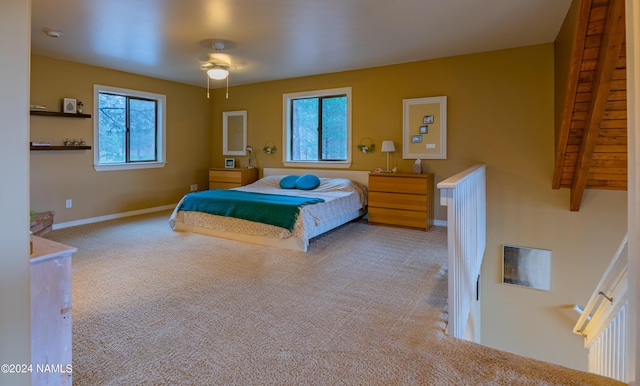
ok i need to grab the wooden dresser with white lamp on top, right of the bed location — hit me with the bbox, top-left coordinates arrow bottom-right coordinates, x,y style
368,173 -> 434,231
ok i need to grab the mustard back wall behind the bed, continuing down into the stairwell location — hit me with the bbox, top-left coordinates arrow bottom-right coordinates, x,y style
211,44 -> 627,370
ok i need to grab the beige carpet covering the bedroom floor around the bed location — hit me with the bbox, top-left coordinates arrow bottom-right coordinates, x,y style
48,213 -> 620,385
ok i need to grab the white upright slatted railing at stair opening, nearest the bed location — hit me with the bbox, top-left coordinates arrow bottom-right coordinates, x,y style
438,165 -> 487,340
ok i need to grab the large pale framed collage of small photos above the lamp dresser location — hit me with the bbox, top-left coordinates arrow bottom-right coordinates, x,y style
402,96 -> 447,159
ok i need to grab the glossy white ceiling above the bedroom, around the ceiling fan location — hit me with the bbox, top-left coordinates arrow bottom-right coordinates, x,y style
31,0 -> 571,87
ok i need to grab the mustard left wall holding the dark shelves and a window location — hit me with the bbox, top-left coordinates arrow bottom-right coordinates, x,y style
31,55 -> 211,223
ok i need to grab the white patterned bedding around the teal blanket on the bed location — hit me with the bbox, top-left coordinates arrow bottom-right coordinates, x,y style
169,175 -> 367,249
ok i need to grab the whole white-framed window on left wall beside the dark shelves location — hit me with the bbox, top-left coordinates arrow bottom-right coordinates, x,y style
93,85 -> 166,171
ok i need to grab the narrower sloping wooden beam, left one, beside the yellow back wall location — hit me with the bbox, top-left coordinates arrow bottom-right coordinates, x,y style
551,0 -> 592,189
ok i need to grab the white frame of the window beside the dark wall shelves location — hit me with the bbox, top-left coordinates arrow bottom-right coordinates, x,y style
93,84 -> 167,172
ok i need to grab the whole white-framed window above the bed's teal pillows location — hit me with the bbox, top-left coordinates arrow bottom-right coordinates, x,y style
282,87 -> 351,168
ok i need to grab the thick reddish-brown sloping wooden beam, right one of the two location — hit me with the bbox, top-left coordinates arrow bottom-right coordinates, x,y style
569,0 -> 625,211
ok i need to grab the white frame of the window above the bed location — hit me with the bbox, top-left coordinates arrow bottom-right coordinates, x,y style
282,87 -> 353,169
